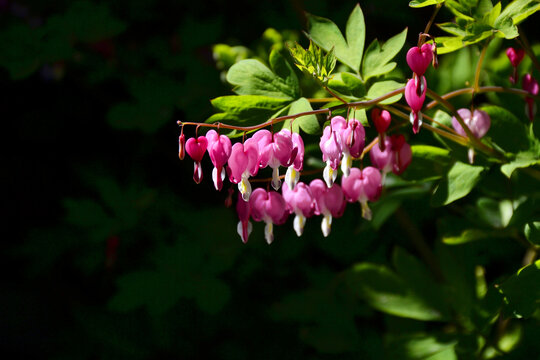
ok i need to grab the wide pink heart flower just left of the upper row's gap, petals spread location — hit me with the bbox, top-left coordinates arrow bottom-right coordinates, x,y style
259,129 -> 298,190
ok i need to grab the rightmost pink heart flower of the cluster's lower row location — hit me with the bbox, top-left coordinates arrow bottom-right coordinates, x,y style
341,166 -> 382,220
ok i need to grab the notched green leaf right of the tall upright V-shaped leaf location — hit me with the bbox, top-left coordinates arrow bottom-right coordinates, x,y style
362,28 -> 407,81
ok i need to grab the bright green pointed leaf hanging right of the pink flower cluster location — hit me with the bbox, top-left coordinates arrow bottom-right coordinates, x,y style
431,161 -> 484,206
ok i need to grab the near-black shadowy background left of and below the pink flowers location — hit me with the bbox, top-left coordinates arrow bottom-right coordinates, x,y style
5,0 -> 536,359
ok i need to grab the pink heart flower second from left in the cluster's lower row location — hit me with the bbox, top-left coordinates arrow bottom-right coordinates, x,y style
249,188 -> 288,244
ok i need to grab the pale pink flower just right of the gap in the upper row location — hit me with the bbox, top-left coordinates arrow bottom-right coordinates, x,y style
319,116 -> 347,187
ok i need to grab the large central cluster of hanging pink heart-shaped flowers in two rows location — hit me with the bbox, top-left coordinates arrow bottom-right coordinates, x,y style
179,109 -> 412,244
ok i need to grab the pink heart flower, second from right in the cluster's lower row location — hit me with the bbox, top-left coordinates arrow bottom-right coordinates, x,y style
309,179 -> 347,237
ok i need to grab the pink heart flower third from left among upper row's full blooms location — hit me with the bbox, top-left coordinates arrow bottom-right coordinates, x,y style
227,139 -> 259,201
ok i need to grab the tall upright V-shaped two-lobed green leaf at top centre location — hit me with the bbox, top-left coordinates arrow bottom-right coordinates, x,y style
307,5 -> 366,72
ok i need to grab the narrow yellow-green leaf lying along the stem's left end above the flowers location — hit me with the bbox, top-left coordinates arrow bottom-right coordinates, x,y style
206,95 -> 290,125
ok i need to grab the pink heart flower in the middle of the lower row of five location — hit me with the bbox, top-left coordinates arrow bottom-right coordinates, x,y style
281,182 -> 315,236
